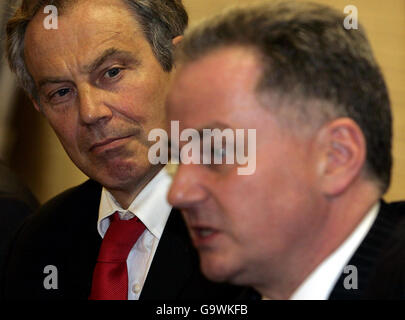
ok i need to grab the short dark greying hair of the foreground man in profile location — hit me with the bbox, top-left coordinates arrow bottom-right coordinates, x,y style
176,1 -> 392,193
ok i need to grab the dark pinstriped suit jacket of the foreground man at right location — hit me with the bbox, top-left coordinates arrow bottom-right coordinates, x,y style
329,201 -> 405,300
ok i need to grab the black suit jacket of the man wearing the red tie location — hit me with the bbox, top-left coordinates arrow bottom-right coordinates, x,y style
4,180 -> 242,300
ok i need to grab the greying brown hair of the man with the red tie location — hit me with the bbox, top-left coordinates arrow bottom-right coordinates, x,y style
6,0 -> 188,98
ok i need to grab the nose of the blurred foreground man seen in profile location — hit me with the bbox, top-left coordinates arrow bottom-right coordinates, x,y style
168,164 -> 208,208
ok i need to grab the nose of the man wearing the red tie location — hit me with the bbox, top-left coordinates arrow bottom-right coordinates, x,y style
79,86 -> 112,125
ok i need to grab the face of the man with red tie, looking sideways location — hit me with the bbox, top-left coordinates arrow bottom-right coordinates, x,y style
25,0 -> 170,195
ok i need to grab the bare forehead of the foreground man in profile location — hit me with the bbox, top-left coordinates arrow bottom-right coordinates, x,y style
167,47 -> 264,127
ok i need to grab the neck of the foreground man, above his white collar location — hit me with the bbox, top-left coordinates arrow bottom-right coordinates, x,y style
253,180 -> 380,300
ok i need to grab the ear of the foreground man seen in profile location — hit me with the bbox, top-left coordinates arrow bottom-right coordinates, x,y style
317,118 -> 367,196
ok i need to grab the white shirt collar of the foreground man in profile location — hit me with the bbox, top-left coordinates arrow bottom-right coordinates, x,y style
290,202 -> 380,300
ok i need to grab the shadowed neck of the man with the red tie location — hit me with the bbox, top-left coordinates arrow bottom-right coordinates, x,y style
108,165 -> 163,210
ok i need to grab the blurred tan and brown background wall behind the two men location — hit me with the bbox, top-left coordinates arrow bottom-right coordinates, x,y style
0,0 -> 405,203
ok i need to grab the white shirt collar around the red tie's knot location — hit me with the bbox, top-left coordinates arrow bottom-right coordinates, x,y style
97,168 -> 172,239
